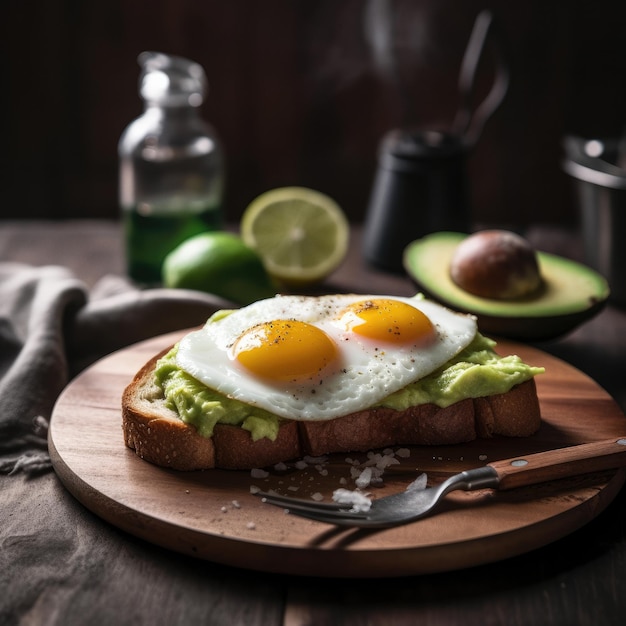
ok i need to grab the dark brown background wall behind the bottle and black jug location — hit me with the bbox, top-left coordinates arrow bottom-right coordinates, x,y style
0,0 -> 626,225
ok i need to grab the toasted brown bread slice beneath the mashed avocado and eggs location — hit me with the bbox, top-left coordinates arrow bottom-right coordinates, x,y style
122,348 -> 541,471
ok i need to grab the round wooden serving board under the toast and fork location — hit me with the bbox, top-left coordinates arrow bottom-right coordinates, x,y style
49,333 -> 626,577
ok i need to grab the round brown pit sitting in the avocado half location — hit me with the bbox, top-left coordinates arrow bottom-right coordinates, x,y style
450,230 -> 543,300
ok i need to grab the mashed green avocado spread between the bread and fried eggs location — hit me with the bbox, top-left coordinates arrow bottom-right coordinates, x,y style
155,333 -> 544,441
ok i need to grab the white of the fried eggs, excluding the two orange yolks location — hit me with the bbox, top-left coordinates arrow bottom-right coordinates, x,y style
176,294 -> 476,421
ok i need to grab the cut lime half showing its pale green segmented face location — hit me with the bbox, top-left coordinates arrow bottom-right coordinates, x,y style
241,187 -> 350,287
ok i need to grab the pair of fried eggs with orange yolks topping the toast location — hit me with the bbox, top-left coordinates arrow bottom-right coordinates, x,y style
176,294 -> 476,420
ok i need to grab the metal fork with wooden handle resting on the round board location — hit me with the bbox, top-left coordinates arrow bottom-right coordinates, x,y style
256,437 -> 626,528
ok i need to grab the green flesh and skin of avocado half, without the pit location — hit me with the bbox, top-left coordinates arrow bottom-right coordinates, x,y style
403,232 -> 609,341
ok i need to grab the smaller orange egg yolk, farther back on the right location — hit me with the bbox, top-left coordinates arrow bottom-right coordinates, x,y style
340,299 -> 434,345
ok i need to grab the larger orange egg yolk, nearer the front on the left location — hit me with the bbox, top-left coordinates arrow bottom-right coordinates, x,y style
233,320 -> 338,382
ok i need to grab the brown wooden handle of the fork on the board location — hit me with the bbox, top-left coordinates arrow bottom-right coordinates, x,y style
489,437 -> 626,489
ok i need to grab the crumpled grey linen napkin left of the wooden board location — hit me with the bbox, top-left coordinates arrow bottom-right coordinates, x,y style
0,263 -> 235,474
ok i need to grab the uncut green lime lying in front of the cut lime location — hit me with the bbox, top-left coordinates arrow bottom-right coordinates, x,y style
162,231 -> 276,305
